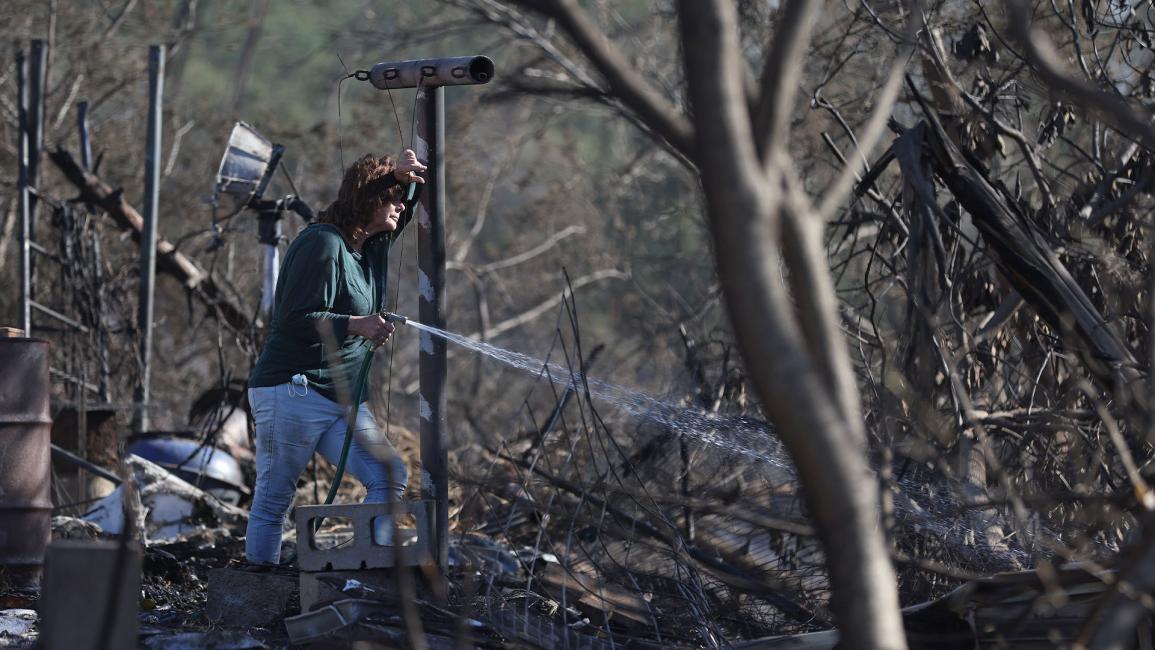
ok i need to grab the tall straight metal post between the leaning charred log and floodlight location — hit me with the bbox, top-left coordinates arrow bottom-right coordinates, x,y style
135,45 -> 164,432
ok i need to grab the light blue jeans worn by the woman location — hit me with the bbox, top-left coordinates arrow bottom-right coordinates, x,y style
245,383 -> 409,563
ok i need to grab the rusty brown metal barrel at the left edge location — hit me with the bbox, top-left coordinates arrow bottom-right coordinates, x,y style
0,338 -> 52,589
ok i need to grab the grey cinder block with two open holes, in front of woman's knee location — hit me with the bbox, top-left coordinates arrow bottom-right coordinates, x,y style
297,500 -> 433,571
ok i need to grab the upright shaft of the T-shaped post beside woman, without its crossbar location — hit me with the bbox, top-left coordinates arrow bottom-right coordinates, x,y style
416,85 -> 449,568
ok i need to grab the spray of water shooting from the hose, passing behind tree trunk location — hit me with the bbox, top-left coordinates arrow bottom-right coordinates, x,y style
408,321 -> 1058,565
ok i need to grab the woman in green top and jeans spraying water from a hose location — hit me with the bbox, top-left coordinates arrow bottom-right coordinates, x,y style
245,149 -> 425,565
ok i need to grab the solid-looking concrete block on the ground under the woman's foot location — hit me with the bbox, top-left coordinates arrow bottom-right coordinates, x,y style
204,567 -> 299,627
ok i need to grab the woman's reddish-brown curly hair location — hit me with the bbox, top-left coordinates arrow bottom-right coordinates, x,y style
316,155 -> 404,234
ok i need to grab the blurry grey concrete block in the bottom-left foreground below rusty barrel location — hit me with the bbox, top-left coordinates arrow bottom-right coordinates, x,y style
40,539 -> 141,650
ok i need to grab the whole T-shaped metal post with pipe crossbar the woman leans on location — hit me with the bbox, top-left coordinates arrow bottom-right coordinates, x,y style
358,55 -> 494,569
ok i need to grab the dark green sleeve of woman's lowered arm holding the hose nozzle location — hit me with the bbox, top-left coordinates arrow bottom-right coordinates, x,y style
277,233 -> 349,344
